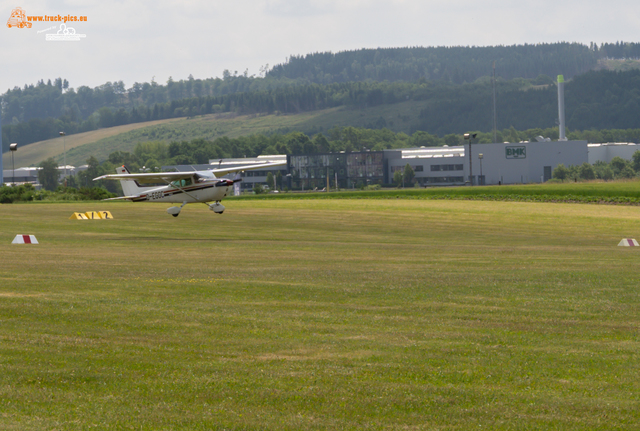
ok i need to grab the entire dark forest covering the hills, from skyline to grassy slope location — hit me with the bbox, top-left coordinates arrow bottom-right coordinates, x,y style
2,42 -> 640,149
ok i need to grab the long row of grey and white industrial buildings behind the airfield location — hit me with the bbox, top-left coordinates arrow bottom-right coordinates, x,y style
201,140 -> 640,191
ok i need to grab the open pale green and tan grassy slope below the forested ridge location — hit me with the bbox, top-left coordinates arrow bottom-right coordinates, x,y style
3,101 -> 425,168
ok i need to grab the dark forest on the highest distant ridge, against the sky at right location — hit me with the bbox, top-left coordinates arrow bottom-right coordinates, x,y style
267,42 -> 620,84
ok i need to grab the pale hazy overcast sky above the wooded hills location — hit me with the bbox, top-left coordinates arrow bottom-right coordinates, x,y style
0,0 -> 640,93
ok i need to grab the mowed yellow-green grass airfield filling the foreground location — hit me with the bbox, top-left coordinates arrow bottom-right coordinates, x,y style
0,199 -> 640,430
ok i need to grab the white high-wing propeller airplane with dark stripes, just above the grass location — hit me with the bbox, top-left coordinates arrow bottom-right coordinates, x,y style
93,161 -> 287,217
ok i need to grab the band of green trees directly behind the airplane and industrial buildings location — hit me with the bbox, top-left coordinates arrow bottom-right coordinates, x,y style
91,127 -> 640,171
